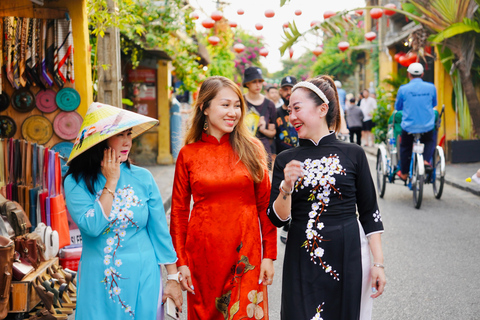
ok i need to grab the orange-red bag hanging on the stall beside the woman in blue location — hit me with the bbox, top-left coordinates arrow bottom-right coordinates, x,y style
50,152 -> 70,248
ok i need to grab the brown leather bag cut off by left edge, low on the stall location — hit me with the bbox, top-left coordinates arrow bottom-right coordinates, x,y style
0,236 -> 14,319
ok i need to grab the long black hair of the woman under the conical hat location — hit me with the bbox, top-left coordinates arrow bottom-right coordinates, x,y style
64,140 -> 130,194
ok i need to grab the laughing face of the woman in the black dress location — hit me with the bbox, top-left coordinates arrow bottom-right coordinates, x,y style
288,88 -> 328,141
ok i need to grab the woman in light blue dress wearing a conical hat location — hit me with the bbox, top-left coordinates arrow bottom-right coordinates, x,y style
64,103 -> 183,320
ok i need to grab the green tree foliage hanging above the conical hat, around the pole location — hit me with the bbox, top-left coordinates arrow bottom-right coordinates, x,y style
87,0 -> 204,91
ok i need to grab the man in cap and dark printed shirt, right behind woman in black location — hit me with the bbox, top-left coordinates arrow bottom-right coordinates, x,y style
275,76 -> 298,243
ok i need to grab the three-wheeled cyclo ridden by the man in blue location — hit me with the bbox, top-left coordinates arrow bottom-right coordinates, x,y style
376,108 -> 445,209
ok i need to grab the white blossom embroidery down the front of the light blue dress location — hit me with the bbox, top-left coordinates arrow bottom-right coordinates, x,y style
99,185 -> 143,318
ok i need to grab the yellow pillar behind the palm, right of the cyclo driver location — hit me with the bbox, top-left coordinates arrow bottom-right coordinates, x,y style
435,48 -> 456,140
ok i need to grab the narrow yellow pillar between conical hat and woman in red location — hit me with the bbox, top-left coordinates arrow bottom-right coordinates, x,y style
157,60 -> 173,164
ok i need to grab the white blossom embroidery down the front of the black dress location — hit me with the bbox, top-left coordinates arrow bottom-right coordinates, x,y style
295,154 -> 346,280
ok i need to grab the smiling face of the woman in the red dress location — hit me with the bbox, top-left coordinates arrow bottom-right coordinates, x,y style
203,87 -> 242,139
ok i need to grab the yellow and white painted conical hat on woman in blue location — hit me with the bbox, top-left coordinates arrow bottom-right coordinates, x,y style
67,102 -> 158,165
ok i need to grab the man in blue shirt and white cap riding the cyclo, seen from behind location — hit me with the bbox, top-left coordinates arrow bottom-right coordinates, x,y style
395,62 -> 437,181
